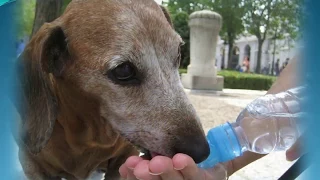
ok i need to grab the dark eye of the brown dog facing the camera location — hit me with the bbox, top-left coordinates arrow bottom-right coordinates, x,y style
108,62 -> 140,85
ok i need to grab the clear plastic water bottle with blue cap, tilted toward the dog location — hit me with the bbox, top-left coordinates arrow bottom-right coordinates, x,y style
198,86 -> 305,168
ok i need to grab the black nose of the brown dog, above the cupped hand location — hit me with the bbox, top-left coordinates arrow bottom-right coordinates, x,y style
175,136 -> 210,164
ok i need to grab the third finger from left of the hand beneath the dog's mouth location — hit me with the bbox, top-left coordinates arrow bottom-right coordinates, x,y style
149,156 -> 183,180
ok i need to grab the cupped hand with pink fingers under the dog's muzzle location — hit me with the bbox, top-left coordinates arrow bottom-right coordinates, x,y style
119,154 -> 227,180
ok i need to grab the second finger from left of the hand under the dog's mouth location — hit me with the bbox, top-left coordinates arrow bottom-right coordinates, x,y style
133,160 -> 161,180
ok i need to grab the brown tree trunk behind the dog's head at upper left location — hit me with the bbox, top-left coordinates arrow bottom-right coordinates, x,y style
31,0 -> 63,37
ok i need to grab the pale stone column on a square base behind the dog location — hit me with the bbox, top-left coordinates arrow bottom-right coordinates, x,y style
182,10 -> 223,91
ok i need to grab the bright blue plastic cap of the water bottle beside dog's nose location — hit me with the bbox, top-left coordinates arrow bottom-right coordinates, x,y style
198,123 -> 242,169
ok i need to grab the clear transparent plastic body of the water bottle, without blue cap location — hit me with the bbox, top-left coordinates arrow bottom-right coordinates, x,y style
238,87 -> 304,154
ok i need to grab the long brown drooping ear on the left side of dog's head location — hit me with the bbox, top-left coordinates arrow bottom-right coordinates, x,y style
17,24 -> 69,154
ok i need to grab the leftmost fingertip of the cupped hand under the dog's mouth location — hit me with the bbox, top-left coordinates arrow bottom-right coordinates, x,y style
119,156 -> 143,180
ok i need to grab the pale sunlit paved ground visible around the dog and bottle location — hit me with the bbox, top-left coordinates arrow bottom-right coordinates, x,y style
13,89 -> 304,180
